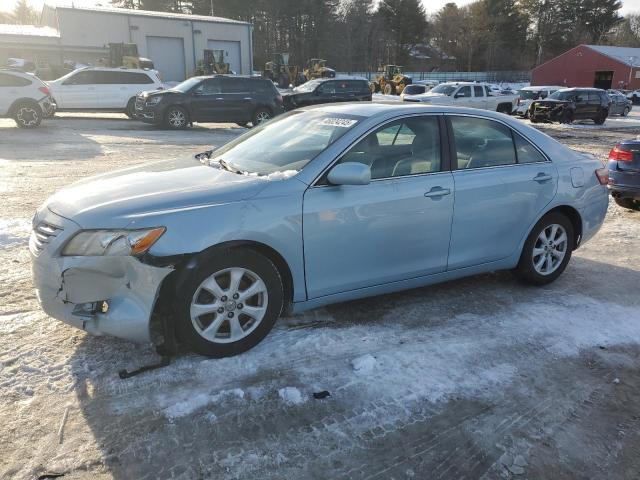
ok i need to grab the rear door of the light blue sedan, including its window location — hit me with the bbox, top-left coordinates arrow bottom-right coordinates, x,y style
448,116 -> 558,270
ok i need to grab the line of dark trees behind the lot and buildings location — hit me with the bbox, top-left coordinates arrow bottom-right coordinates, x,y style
102,0 -> 640,71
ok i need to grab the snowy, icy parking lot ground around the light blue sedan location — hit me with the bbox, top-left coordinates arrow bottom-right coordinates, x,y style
0,113 -> 640,479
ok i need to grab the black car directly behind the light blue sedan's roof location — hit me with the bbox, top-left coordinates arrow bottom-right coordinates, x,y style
282,78 -> 371,110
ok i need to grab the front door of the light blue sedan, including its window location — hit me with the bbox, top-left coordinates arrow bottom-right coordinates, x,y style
303,115 -> 454,298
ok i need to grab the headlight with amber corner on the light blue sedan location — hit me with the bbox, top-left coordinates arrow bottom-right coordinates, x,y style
62,227 -> 166,256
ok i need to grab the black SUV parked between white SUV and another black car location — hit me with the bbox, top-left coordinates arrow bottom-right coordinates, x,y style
135,75 -> 284,129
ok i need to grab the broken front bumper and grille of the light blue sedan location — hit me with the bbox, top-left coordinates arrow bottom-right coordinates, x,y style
29,210 -> 172,342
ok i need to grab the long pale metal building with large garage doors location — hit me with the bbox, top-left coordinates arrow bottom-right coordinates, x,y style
0,5 -> 253,81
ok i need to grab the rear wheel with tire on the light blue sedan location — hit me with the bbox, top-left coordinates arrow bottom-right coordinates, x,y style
514,213 -> 574,285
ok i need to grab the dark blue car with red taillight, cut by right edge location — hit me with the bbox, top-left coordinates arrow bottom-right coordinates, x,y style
609,140 -> 640,210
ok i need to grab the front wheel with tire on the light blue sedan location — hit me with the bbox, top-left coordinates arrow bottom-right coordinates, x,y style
175,249 -> 284,358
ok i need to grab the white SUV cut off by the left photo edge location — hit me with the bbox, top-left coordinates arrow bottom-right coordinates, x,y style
0,69 -> 56,128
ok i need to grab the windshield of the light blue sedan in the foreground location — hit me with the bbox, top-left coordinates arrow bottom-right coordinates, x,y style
209,110 -> 363,177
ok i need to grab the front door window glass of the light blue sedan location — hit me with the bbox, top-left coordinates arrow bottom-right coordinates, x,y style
339,115 -> 441,180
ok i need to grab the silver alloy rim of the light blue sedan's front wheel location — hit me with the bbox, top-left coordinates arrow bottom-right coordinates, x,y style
190,268 -> 269,343
